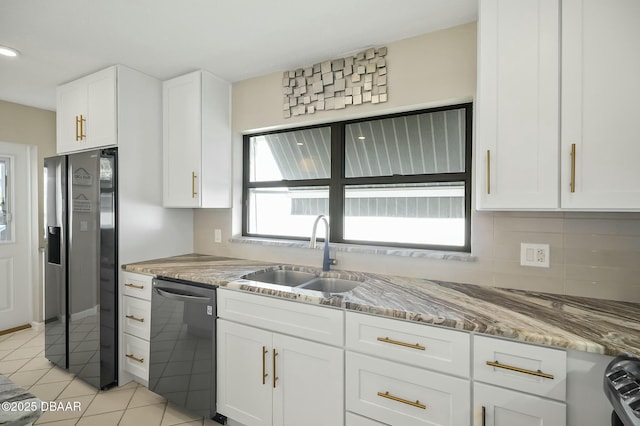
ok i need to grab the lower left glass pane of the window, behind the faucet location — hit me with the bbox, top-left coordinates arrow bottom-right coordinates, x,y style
247,186 -> 329,238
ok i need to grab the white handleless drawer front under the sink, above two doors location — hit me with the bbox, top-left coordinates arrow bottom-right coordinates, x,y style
217,289 -> 344,346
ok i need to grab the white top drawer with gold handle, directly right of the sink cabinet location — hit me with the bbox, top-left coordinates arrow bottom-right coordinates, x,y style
345,312 -> 471,377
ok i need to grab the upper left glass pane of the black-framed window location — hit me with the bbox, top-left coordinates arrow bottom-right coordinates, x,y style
249,127 -> 331,182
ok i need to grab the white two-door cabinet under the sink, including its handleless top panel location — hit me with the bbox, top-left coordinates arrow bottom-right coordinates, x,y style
216,289 -> 344,426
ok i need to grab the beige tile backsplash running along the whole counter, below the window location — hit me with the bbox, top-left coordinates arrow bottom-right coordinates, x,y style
194,210 -> 640,302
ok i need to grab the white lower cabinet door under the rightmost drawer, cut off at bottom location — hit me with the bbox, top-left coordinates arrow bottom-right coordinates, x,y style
473,383 -> 567,426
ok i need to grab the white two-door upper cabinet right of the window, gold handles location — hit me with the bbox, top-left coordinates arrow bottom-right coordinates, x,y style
475,0 -> 640,211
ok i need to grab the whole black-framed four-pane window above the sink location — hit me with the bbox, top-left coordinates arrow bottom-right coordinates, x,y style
243,104 -> 472,251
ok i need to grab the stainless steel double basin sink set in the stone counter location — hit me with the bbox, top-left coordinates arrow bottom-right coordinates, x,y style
242,267 -> 361,293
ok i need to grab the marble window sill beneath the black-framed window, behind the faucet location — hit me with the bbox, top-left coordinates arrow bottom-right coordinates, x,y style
229,237 -> 477,262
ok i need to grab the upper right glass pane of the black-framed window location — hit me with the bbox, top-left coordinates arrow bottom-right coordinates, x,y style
345,109 -> 466,177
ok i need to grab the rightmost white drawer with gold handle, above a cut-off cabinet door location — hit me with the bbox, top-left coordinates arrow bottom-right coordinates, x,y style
473,336 -> 567,401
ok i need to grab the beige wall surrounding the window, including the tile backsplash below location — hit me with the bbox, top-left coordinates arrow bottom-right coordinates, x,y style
194,24 -> 640,301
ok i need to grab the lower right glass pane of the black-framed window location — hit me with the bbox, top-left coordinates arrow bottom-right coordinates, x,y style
344,182 -> 465,246
